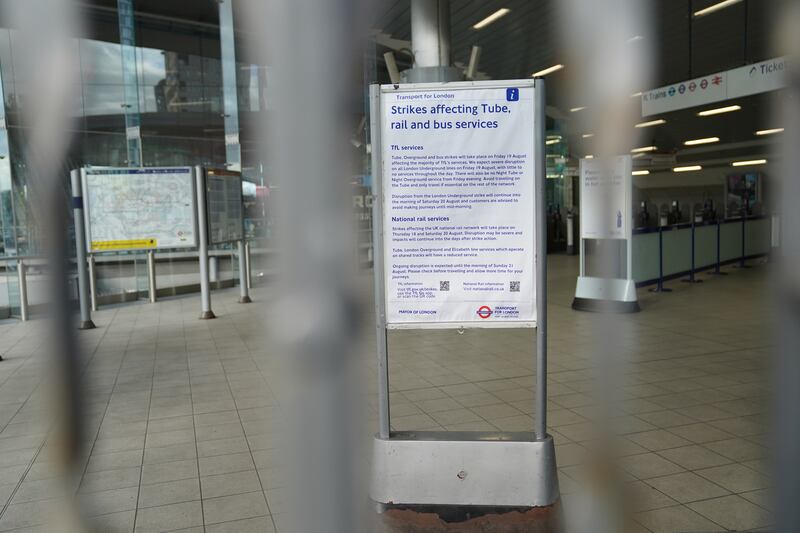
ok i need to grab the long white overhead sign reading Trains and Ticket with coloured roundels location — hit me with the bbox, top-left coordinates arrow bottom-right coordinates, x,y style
642,58 -> 786,117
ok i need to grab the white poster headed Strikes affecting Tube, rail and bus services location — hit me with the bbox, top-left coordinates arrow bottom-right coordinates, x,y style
381,80 -> 536,328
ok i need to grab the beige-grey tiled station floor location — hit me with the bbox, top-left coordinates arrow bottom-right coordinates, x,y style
0,256 -> 772,533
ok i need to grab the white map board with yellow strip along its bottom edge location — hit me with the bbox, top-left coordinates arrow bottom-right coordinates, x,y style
83,167 -> 197,252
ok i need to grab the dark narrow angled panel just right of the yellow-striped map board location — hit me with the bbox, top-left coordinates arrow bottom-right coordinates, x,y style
206,169 -> 244,244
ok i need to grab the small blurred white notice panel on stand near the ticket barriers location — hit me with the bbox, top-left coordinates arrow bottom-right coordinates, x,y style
580,155 -> 632,239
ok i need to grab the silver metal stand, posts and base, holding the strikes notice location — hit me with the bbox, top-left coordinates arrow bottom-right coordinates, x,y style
370,79 -> 559,510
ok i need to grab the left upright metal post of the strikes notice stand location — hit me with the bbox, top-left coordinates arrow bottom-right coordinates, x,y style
369,85 -> 391,439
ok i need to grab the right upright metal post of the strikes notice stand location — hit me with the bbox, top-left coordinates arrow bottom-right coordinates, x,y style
534,78 -> 547,440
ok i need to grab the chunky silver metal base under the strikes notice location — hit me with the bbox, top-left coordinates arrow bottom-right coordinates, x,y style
370,432 -> 559,508
